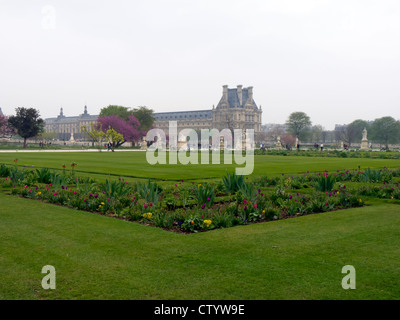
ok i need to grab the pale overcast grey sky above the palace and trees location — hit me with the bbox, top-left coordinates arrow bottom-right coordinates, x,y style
0,0 -> 400,130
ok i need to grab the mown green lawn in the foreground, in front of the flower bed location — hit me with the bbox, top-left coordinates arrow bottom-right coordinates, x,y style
0,193 -> 400,299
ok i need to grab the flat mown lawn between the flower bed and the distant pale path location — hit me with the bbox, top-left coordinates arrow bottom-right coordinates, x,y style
0,151 -> 400,181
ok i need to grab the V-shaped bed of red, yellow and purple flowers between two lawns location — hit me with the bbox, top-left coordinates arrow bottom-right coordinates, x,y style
0,163 -> 388,232
